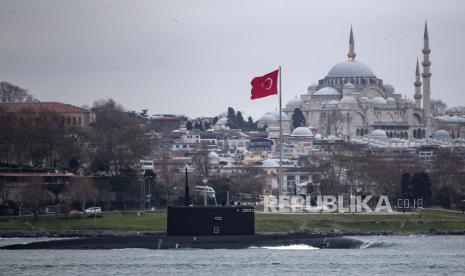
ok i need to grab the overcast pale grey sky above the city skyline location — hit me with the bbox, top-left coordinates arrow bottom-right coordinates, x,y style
0,0 -> 465,119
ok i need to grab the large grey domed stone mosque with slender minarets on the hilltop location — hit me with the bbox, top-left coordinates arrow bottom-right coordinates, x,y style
258,23 -> 432,140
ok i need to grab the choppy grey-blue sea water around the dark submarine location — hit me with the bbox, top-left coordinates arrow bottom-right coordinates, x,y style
0,235 -> 465,276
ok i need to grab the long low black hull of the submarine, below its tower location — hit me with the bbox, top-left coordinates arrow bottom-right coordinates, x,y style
0,234 -> 363,250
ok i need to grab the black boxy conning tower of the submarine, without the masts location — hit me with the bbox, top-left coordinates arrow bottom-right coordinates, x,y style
166,205 -> 255,236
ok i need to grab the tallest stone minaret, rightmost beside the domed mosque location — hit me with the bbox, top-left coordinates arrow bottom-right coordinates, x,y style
422,21 -> 432,137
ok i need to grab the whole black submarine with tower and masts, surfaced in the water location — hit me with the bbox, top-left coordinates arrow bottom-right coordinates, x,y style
0,171 -> 364,250
